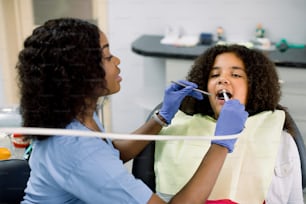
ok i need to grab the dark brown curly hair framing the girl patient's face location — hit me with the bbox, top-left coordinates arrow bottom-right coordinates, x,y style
180,44 -> 294,135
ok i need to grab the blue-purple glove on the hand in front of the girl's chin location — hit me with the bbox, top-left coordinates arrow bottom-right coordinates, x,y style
211,99 -> 249,153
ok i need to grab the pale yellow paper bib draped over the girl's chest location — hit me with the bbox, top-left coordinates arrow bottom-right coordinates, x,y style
154,110 -> 285,203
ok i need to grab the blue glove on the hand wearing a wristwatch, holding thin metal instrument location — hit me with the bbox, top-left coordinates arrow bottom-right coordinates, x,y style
159,80 -> 203,124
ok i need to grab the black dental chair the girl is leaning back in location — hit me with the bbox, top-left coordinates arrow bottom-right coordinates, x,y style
132,103 -> 306,192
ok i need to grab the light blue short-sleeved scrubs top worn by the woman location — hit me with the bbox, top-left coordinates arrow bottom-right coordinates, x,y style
21,116 -> 152,204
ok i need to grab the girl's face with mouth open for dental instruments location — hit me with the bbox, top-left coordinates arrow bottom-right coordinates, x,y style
207,53 -> 248,118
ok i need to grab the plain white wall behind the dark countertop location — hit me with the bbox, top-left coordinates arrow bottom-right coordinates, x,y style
107,0 -> 306,132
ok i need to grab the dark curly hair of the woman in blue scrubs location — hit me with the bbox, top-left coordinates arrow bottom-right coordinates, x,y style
16,18 -> 107,139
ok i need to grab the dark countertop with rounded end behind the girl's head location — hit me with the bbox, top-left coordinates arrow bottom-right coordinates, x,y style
132,35 -> 306,69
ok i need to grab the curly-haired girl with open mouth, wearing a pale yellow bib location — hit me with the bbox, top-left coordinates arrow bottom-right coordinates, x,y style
154,45 -> 303,204
